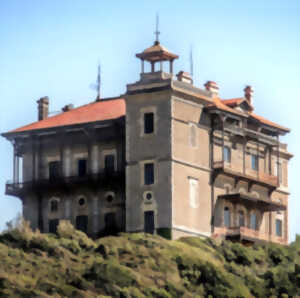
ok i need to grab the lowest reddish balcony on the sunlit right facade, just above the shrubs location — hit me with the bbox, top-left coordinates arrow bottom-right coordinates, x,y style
213,227 -> 288,245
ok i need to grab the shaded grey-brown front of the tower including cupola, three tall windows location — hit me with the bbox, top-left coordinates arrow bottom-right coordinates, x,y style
125,37 -> 178,233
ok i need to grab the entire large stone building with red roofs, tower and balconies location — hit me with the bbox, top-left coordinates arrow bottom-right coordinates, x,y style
3,41 -> 292,244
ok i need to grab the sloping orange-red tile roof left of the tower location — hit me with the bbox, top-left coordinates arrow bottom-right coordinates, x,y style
9,98 -> 126,133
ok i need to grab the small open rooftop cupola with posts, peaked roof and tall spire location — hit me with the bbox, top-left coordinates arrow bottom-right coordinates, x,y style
136,18 -> 179,74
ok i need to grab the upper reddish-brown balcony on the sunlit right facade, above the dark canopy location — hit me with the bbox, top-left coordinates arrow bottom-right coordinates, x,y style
213,161 -> 279,191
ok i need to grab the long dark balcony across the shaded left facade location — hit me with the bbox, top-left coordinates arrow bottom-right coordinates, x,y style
5,171 -> 125,197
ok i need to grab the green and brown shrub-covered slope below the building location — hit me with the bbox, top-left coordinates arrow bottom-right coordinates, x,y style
0,224 -> 300,297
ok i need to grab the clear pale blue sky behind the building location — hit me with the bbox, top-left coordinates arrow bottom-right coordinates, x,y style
0,0 -> 300,240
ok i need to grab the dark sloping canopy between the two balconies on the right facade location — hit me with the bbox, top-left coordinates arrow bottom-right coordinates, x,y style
218,193 -> 286,212
